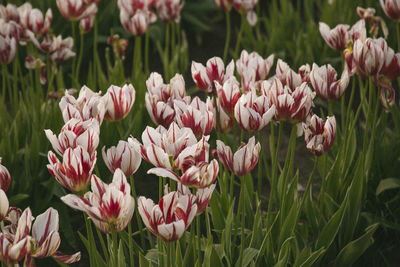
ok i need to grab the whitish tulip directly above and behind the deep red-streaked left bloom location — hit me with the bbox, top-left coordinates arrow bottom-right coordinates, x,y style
44,118 -> 100,156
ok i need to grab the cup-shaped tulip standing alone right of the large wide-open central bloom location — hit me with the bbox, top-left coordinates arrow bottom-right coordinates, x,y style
217,136 -> 261,176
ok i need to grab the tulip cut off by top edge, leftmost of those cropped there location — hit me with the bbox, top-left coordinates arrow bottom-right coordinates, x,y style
56,0 -> 97,21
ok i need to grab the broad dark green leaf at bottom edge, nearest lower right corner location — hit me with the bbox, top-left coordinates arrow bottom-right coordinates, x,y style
334,223 -> 379,266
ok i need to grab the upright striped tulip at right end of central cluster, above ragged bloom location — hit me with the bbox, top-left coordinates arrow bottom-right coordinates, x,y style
310,63 -> 350,101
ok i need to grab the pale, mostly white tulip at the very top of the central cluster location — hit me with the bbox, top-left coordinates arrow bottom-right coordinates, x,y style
236,50 -> 274,82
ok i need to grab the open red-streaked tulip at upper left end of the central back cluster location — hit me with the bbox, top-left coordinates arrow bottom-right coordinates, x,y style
191,57 -> 235,94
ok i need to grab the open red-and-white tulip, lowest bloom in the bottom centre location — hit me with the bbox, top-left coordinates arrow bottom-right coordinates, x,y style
138,192 -> 197,242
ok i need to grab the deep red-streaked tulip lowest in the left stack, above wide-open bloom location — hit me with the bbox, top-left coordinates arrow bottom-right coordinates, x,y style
47,145 -> 96,192
